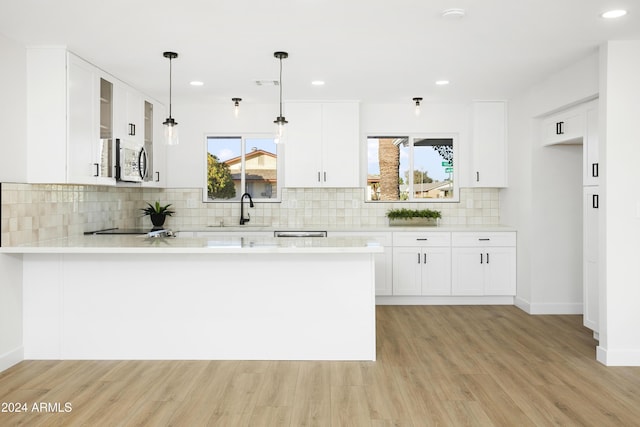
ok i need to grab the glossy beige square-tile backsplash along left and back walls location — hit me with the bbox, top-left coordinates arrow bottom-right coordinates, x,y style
1,183 -> 500,246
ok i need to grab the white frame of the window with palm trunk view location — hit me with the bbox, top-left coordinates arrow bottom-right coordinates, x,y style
364,132 -> 460,204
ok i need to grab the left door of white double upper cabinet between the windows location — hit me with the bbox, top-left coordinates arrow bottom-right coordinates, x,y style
284,103 -> 324,187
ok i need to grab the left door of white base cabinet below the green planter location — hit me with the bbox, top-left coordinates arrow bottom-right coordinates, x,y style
393,247 -> 423,295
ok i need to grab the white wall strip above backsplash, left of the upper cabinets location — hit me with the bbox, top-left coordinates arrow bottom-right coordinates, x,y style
0,34 -> 27,182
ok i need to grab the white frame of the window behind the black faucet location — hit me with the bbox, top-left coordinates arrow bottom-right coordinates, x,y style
202,132 -> 284,203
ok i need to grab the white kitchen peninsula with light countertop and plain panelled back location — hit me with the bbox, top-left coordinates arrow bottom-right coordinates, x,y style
0,236 -> 383,360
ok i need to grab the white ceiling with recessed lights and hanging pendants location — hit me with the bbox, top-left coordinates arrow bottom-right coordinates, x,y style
0,0 -> 640,104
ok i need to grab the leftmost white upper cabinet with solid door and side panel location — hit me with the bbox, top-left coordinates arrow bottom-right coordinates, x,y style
27,48 -> 115,185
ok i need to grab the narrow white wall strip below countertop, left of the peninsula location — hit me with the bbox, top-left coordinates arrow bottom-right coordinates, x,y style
0,254 -> 23,371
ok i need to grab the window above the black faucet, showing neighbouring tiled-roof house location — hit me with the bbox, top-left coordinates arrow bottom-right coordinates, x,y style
206,136 -> 281,202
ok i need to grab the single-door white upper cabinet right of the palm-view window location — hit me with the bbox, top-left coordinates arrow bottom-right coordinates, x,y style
471,101 -> 507,187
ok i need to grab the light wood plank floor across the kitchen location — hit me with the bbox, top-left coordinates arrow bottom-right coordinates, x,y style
0,306 -> 640,426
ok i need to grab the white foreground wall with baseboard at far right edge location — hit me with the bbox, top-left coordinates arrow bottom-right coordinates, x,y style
597,41 -> 640,366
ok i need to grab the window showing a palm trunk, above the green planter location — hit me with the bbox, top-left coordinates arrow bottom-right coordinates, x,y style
366,134 -> 459,202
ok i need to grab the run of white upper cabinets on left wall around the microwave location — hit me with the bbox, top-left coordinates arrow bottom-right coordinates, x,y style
27,48 -> 165,185
